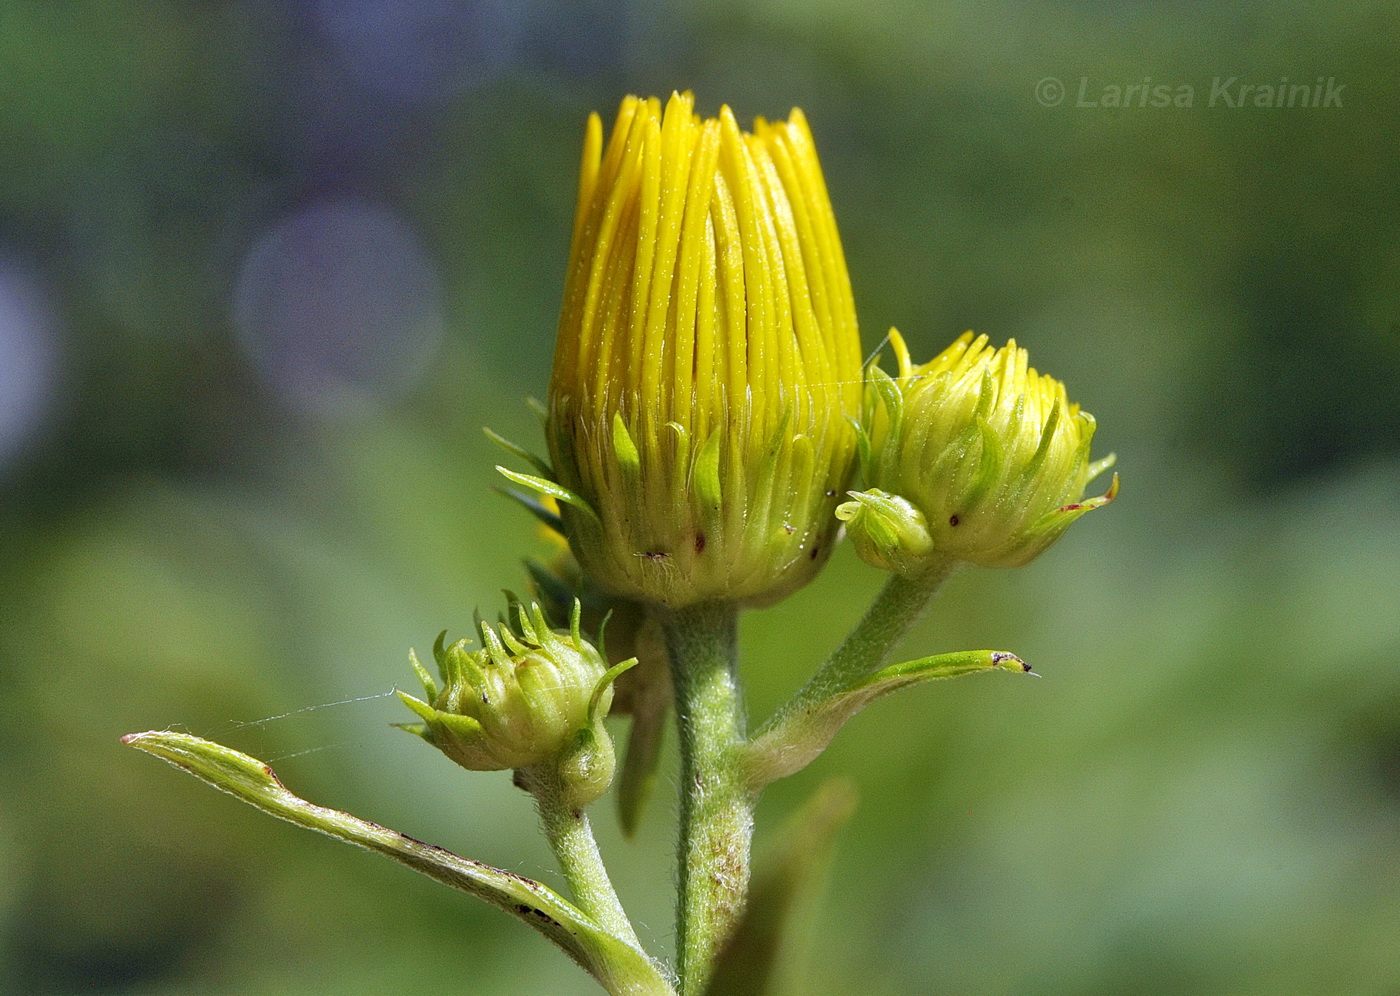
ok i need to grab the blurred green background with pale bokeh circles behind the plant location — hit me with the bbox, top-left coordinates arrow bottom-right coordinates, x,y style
0,0 -> 1400,996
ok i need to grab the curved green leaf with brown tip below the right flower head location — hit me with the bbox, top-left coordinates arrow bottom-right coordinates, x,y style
745,650 -> 1033,790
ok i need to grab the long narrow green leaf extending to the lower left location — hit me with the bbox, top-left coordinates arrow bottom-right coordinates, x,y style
122,730 -> 675,996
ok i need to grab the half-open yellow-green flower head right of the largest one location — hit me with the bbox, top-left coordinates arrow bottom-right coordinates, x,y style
837,329 -> 1119,576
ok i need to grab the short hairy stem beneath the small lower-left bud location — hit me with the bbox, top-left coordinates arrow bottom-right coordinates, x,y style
517,769 -> 641,948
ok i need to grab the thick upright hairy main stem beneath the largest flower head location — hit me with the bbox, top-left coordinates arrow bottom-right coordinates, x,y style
659,604 -> 753,996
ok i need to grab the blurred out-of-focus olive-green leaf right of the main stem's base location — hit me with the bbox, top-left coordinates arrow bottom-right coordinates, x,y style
706,779 -> 855,996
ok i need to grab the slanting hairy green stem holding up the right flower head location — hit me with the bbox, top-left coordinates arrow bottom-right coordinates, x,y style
759,560 -> 958,735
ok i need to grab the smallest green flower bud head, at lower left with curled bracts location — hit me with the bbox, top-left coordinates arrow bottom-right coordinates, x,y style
399,602 -> 636,805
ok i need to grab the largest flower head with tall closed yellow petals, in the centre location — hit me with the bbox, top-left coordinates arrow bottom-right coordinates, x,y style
547,94 -> 861,608
